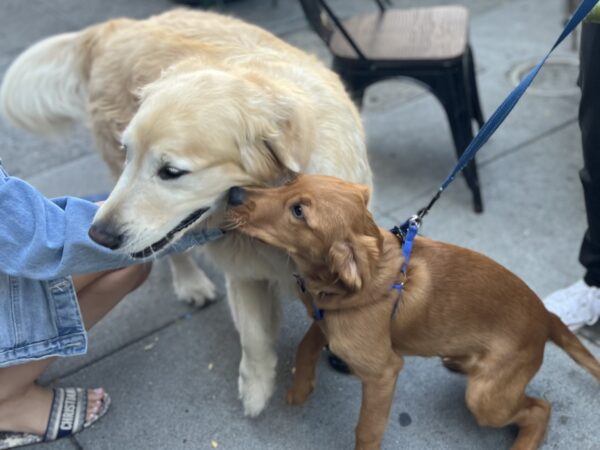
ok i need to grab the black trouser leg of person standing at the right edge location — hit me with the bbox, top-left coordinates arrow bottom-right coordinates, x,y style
579,24 -> 600,287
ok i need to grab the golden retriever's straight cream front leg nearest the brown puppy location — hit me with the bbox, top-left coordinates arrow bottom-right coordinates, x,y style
227,274 -> 280,417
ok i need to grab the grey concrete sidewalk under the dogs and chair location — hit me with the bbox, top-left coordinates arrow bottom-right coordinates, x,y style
0,0 -> 600,450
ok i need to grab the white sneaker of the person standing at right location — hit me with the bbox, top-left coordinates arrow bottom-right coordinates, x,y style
543,280 -> 600,331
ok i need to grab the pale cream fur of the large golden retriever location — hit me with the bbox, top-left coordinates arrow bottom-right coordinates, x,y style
0,10 -> 371,416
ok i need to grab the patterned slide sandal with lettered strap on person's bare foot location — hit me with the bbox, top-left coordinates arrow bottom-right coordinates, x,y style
0,388 -> 110,450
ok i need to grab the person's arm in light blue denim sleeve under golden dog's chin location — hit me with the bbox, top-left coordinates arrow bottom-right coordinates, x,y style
0,177 -> 220,280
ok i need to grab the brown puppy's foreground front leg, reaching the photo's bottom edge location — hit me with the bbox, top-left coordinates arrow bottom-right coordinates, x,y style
355,352 -> 403,450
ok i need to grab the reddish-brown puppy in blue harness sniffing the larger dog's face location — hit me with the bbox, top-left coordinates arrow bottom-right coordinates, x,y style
229,176 -> 600,450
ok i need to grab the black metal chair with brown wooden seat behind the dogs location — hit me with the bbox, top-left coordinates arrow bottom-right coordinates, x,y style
300,0 -> 484,212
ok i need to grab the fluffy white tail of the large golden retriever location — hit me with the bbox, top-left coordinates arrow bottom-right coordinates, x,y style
0,33 -> 87,135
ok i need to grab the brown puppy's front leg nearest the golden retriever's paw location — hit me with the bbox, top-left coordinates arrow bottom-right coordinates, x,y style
287,322 -> 327,405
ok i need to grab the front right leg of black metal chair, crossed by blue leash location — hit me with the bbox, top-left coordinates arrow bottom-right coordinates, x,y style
436,69 -> 483,213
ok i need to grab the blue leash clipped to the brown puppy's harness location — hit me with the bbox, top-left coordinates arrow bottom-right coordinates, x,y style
390,0 -> 600,313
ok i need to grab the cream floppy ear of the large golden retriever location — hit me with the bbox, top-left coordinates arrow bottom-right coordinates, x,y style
239,75 -> 315,181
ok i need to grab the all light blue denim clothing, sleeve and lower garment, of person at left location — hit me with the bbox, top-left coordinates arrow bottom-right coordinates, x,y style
0,161 -> 223,367
